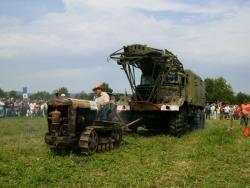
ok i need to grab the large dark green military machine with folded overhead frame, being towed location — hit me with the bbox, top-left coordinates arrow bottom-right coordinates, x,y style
110,44 -> 205,136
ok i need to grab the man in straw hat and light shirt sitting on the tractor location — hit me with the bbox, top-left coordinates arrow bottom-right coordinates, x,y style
93,84 -> 110,120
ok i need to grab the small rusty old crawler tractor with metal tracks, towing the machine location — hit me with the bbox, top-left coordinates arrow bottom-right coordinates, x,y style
45,98 -> 122,155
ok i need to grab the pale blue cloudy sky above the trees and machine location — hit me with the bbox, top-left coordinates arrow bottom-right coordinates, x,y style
0,0 -> 250,93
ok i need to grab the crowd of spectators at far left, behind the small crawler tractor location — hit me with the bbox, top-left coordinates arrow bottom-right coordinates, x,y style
0,98 -> 47,117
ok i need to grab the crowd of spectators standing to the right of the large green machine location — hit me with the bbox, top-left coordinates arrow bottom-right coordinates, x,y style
205,102 -> 241,120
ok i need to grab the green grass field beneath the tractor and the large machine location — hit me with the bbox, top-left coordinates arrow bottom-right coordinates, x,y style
0,118 -> 250,187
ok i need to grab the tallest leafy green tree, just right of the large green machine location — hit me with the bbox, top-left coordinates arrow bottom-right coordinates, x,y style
205,77 -> 235,103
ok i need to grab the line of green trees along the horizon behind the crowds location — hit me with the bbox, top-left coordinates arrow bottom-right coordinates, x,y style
0,77 -> 250,104
